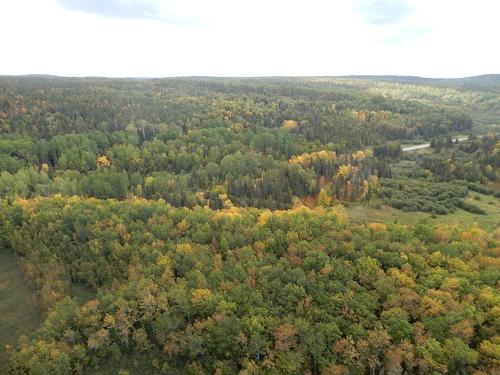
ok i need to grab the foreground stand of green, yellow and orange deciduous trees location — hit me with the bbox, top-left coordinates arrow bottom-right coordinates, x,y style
0,197 -> 500,375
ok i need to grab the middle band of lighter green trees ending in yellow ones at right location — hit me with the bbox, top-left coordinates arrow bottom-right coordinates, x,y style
0,126 -> 380,209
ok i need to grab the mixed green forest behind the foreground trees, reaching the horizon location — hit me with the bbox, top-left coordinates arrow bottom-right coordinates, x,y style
0,77 -> 492,209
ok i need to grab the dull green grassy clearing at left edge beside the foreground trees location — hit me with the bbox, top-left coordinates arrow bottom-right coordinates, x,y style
0,250 -> 43,373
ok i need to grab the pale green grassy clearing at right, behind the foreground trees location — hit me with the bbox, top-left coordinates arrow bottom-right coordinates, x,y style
346,193 -> 500,230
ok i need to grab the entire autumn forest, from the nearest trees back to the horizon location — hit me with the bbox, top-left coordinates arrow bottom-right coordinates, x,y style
0,76 -> 500,375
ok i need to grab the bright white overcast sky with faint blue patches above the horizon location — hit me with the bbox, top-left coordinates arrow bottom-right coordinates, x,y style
0,0 -> 500,77
